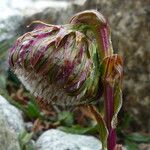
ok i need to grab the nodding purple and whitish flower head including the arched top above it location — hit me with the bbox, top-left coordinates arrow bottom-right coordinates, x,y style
9,11 -> 113,106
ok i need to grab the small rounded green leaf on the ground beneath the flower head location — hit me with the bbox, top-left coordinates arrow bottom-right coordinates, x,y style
58,111 -> 74,126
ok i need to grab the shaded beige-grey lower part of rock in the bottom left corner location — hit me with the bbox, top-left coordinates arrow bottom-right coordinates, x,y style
0,109 -> 20,150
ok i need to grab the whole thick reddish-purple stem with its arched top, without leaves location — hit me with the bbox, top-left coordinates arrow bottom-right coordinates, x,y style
70,11 -> 116,150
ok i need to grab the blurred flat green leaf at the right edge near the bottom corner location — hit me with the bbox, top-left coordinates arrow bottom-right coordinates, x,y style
126,133 -> 150,143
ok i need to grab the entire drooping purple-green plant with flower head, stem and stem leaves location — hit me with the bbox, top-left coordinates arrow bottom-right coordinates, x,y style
9,10 -> 123,150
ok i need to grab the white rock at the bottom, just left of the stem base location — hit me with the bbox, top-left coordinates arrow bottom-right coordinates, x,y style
35,129 -> 101,150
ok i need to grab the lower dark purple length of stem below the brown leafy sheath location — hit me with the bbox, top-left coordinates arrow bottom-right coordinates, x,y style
104,83 -> 116,150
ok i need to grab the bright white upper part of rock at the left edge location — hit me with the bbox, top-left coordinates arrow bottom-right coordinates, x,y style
0,96 -> 25,134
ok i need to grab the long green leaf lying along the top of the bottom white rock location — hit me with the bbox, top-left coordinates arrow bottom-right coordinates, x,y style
58,125 -> 98,134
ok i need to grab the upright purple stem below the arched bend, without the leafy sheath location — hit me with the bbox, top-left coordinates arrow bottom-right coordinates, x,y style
98,24 -> 116,150
